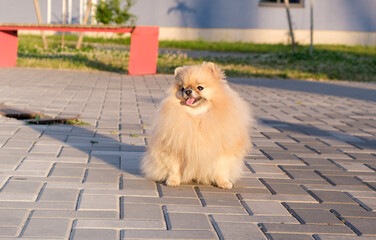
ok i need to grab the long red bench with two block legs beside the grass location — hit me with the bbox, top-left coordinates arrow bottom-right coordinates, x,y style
0,24 -> 159,75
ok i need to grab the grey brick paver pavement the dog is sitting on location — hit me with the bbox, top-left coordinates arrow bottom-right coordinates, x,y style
0,68 -> 376,240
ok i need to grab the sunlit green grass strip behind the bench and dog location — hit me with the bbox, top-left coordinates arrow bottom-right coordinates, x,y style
17,35 -> 376,81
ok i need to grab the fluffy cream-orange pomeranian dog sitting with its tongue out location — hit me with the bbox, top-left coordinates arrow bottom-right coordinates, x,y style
141,62 -> 252,189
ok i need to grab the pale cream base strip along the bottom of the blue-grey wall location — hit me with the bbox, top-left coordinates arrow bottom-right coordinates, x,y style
20,27 -> 376,46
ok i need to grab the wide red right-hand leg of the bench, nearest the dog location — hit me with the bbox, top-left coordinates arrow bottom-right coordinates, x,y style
128,27 -> 159,75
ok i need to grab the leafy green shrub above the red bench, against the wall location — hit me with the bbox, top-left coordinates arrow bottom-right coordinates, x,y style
95,0 -> 137,25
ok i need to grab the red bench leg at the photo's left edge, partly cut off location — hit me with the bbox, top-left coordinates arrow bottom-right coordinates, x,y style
0,31 -> 18,67
